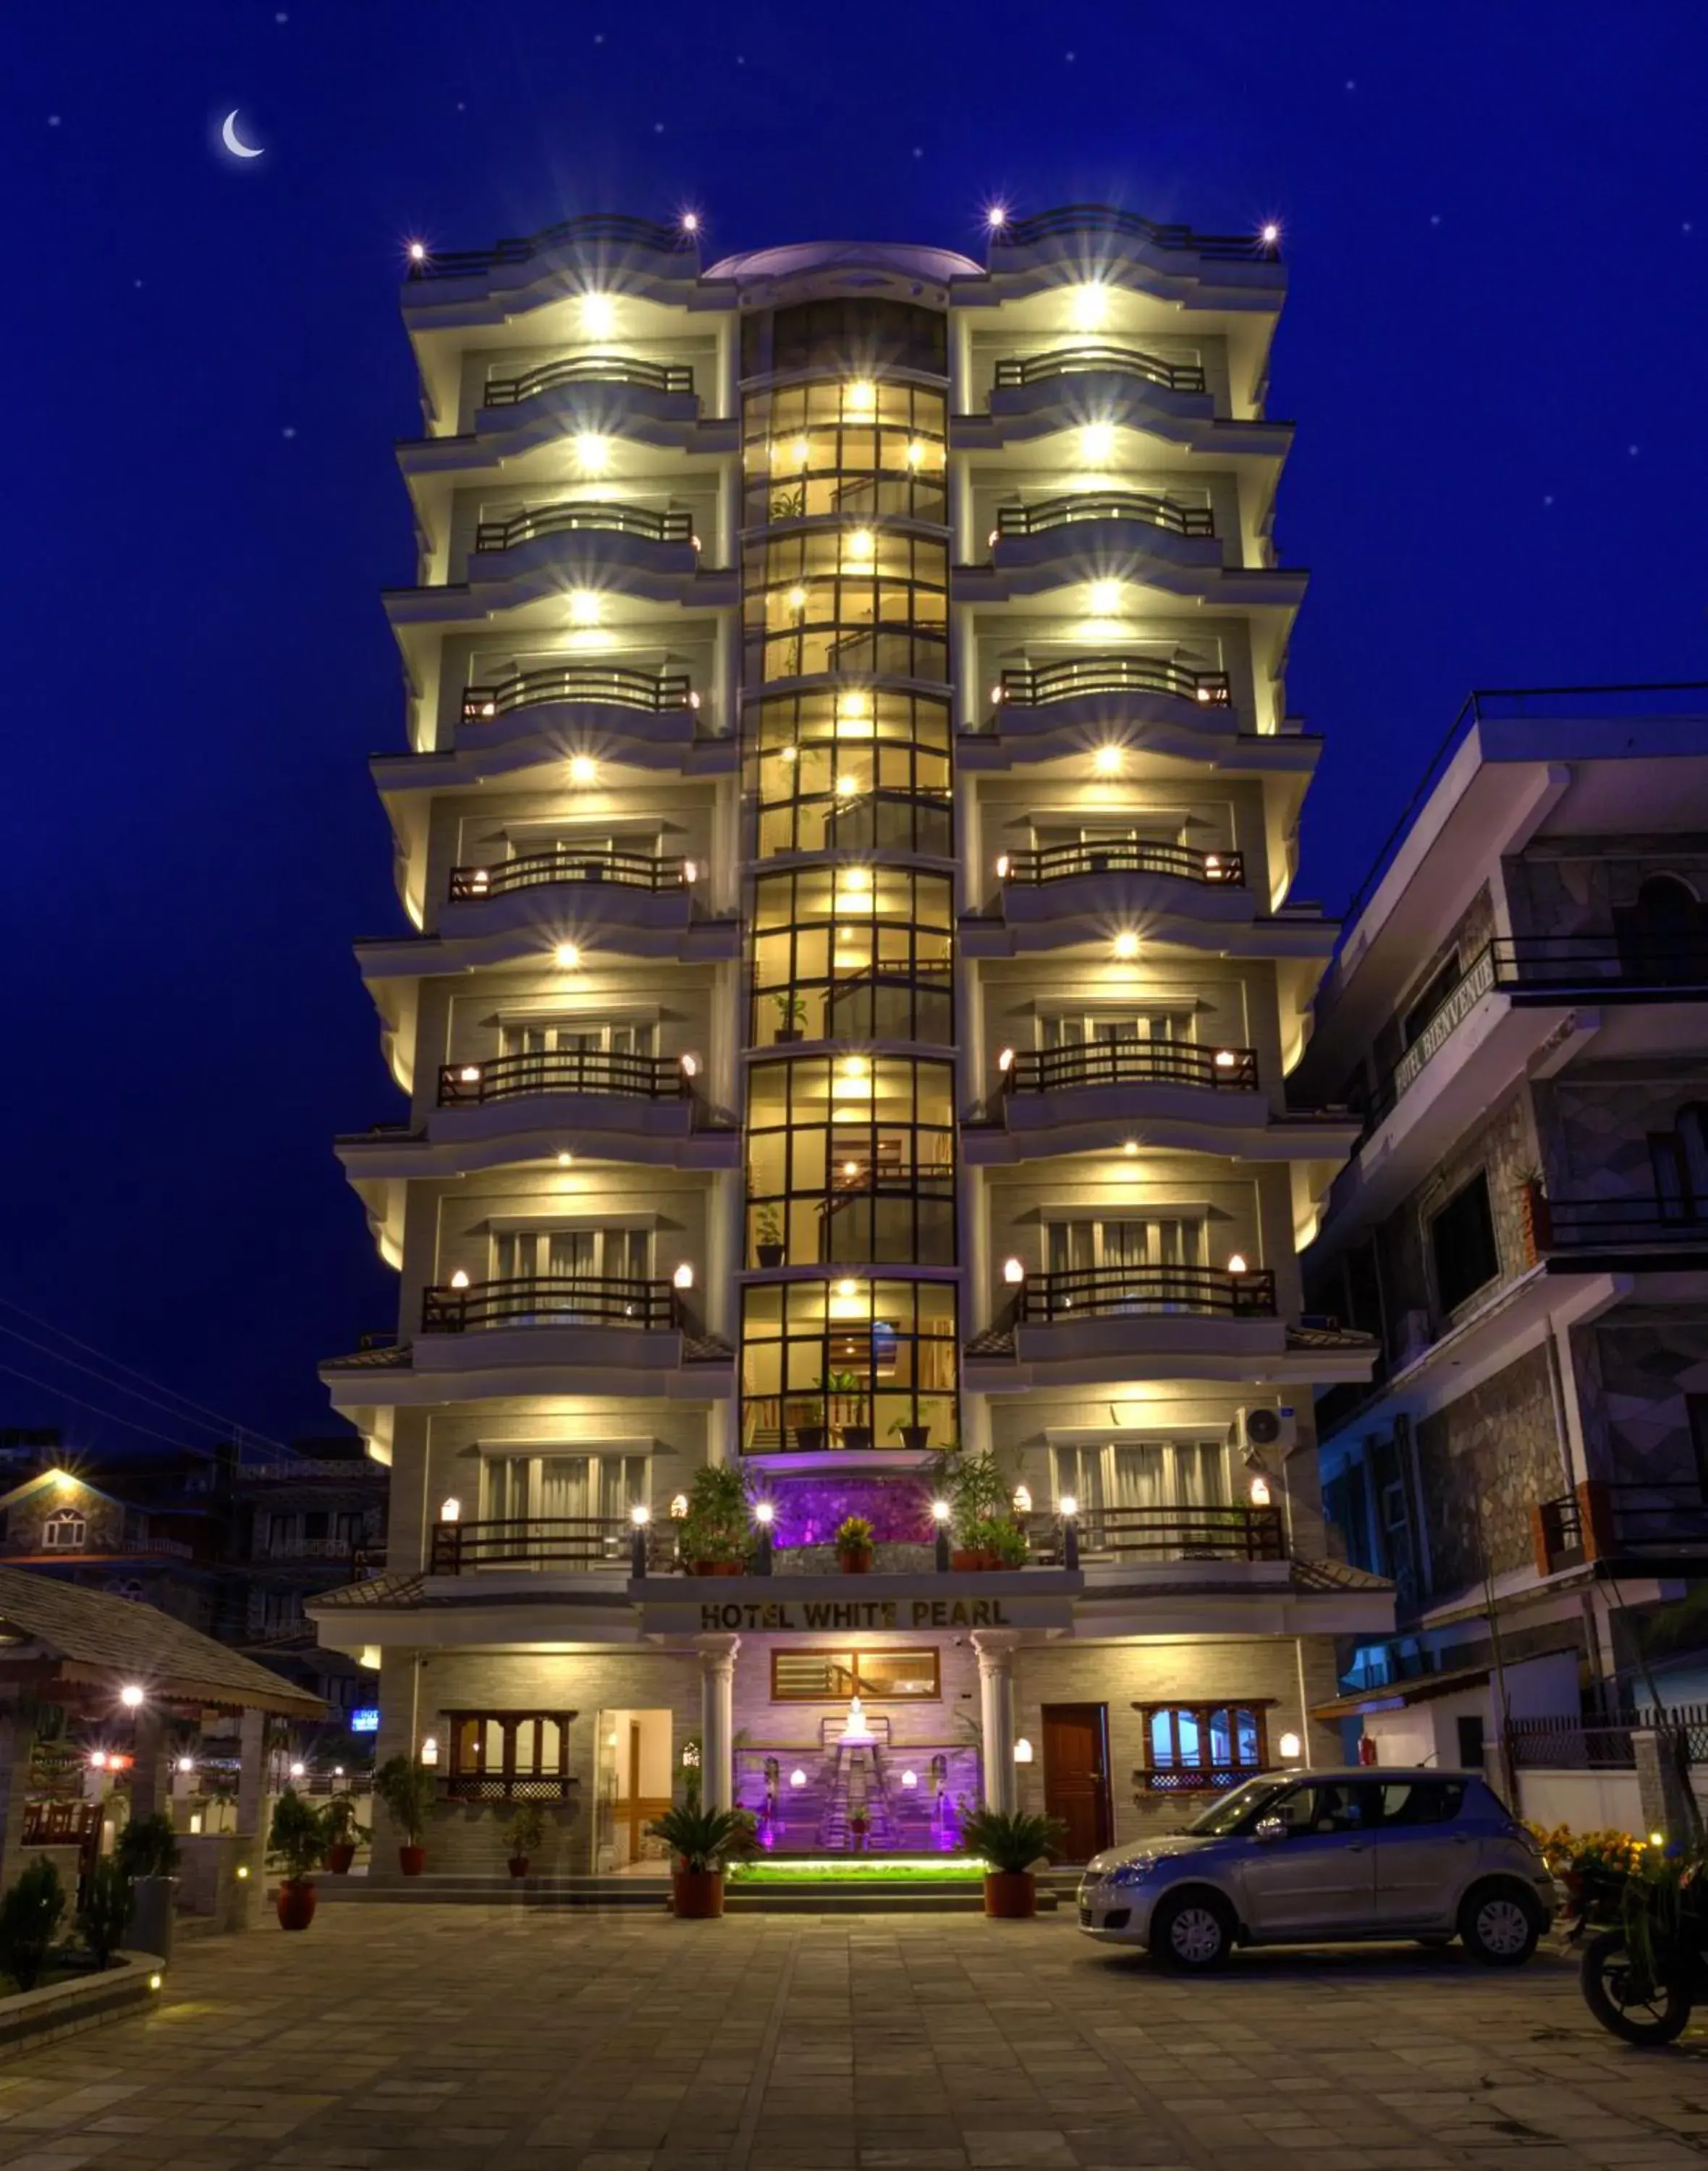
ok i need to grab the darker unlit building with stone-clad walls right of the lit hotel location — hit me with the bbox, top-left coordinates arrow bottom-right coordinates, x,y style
1293,686 -> 1708,1761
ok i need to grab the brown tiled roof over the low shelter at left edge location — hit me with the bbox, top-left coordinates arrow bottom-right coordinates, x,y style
0,1567 -> 326,1719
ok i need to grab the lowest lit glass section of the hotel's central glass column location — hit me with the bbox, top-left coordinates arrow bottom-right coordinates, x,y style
743,1274 -> 957,1455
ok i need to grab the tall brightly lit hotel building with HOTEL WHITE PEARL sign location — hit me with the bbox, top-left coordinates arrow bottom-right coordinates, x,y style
308,195 -> 1391,1869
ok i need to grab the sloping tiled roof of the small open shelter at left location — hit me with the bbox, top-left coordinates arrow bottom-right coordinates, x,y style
0,1567 -> 326,1719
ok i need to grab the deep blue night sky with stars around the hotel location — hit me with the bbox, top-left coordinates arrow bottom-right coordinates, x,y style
0,0 -> 1708,1448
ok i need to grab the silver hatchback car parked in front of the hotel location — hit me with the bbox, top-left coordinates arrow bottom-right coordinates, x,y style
1078,1765 -> 1560,1969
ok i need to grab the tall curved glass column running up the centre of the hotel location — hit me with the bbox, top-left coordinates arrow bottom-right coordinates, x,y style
743,300 -> 959,1455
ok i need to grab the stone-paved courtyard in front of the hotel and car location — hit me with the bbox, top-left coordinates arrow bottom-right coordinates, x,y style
0,1906 -> 1708,2171
